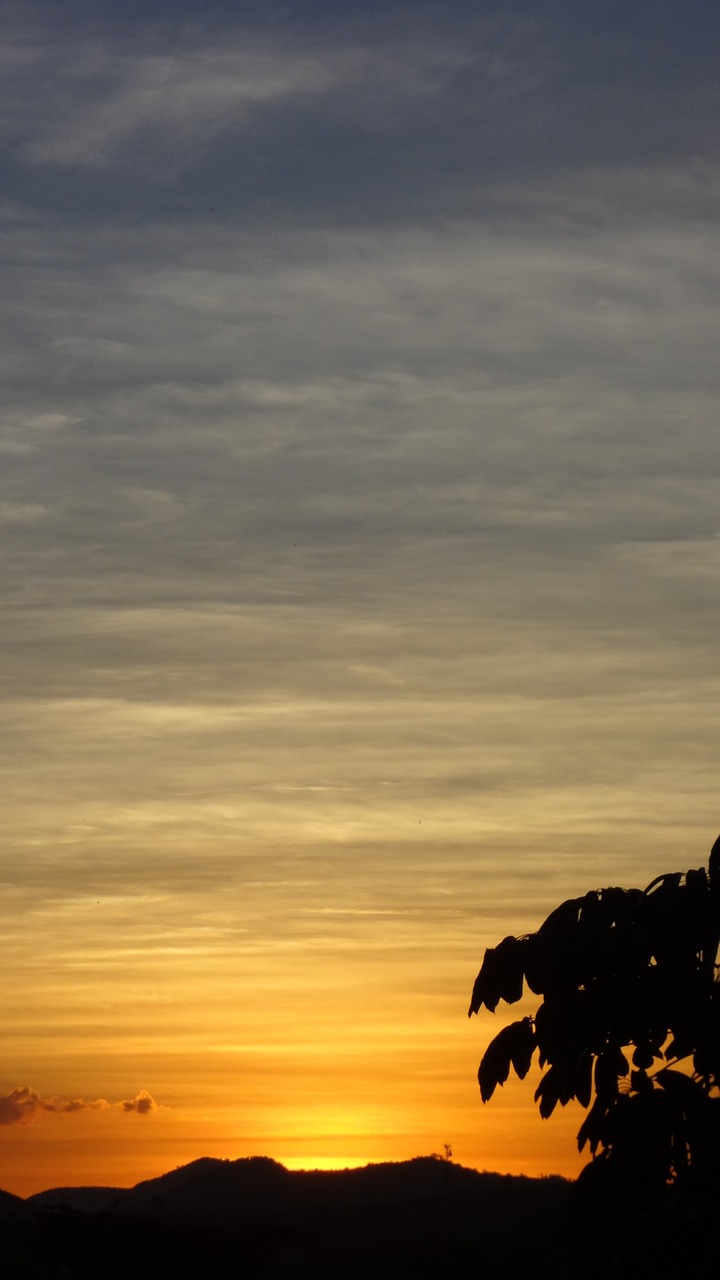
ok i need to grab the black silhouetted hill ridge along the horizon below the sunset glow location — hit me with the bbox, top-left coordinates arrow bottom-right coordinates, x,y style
12,1156 -> 570,1280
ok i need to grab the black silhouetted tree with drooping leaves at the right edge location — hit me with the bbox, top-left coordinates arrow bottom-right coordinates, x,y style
469,837 -> 720,1212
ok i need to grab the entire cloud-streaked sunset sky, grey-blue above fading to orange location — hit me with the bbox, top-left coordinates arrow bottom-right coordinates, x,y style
0,0 -> 720,1194
